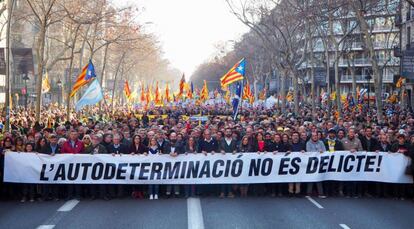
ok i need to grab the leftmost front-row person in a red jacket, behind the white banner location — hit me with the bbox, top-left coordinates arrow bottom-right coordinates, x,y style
60,130 -> 85,200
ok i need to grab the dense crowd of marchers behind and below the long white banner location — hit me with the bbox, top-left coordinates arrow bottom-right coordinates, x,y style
0,105 -> 414,202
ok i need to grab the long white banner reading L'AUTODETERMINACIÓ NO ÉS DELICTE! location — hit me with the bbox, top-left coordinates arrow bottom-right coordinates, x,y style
4,152 -> 413,184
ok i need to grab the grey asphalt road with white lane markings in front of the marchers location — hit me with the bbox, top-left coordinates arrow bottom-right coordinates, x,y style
0,197 -> 414,229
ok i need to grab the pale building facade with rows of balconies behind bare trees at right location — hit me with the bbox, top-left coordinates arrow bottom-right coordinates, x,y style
302,0 -> 400,100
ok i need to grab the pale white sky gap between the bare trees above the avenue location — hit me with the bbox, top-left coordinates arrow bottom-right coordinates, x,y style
130,0 -> 248,78
